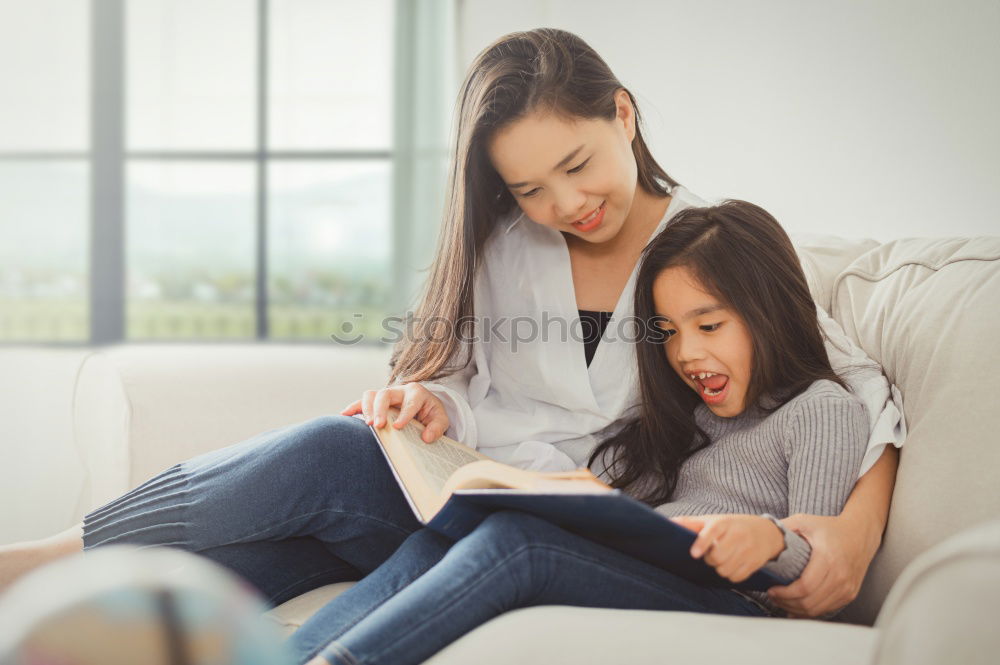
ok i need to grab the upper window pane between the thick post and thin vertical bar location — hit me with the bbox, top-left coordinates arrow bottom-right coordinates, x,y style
125,0 -> 257,150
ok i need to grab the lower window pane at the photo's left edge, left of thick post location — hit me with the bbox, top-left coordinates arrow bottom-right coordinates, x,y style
0,161 -> 90,342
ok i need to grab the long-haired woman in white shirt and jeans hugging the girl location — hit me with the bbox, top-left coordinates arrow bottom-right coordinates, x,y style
0,24 -> 901,648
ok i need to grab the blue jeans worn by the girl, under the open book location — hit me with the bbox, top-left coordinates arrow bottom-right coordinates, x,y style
289,511 -> 769,665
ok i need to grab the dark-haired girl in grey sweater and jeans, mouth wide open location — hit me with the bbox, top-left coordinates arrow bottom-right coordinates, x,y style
291,201 -> 868,665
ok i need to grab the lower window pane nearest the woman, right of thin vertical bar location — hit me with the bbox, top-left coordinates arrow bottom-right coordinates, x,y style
268,161 -> 392,340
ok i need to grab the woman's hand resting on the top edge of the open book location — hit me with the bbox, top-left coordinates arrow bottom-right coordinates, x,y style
340,382 -> 450,443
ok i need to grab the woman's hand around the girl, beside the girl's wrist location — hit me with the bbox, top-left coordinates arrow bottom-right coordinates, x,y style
767,514 -> 879,617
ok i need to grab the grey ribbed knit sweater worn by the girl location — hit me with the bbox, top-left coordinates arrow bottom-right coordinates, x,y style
656,380 -> 868,617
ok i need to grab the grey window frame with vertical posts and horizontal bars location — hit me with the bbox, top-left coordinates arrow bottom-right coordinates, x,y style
0,0 -> 422,347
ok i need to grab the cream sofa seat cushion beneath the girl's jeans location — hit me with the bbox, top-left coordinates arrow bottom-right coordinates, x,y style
264,582 -> 876,665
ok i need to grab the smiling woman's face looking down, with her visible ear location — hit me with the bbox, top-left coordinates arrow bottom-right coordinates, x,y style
487,90 -> 637,243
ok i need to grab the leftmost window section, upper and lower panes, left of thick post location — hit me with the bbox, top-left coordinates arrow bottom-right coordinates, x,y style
0,0 -> 90,342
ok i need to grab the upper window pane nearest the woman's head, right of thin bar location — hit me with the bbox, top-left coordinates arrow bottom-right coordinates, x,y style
268,0 -> 394,149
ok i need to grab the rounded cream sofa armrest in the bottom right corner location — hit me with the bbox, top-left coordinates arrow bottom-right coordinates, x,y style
872,520 -> 1000,665
